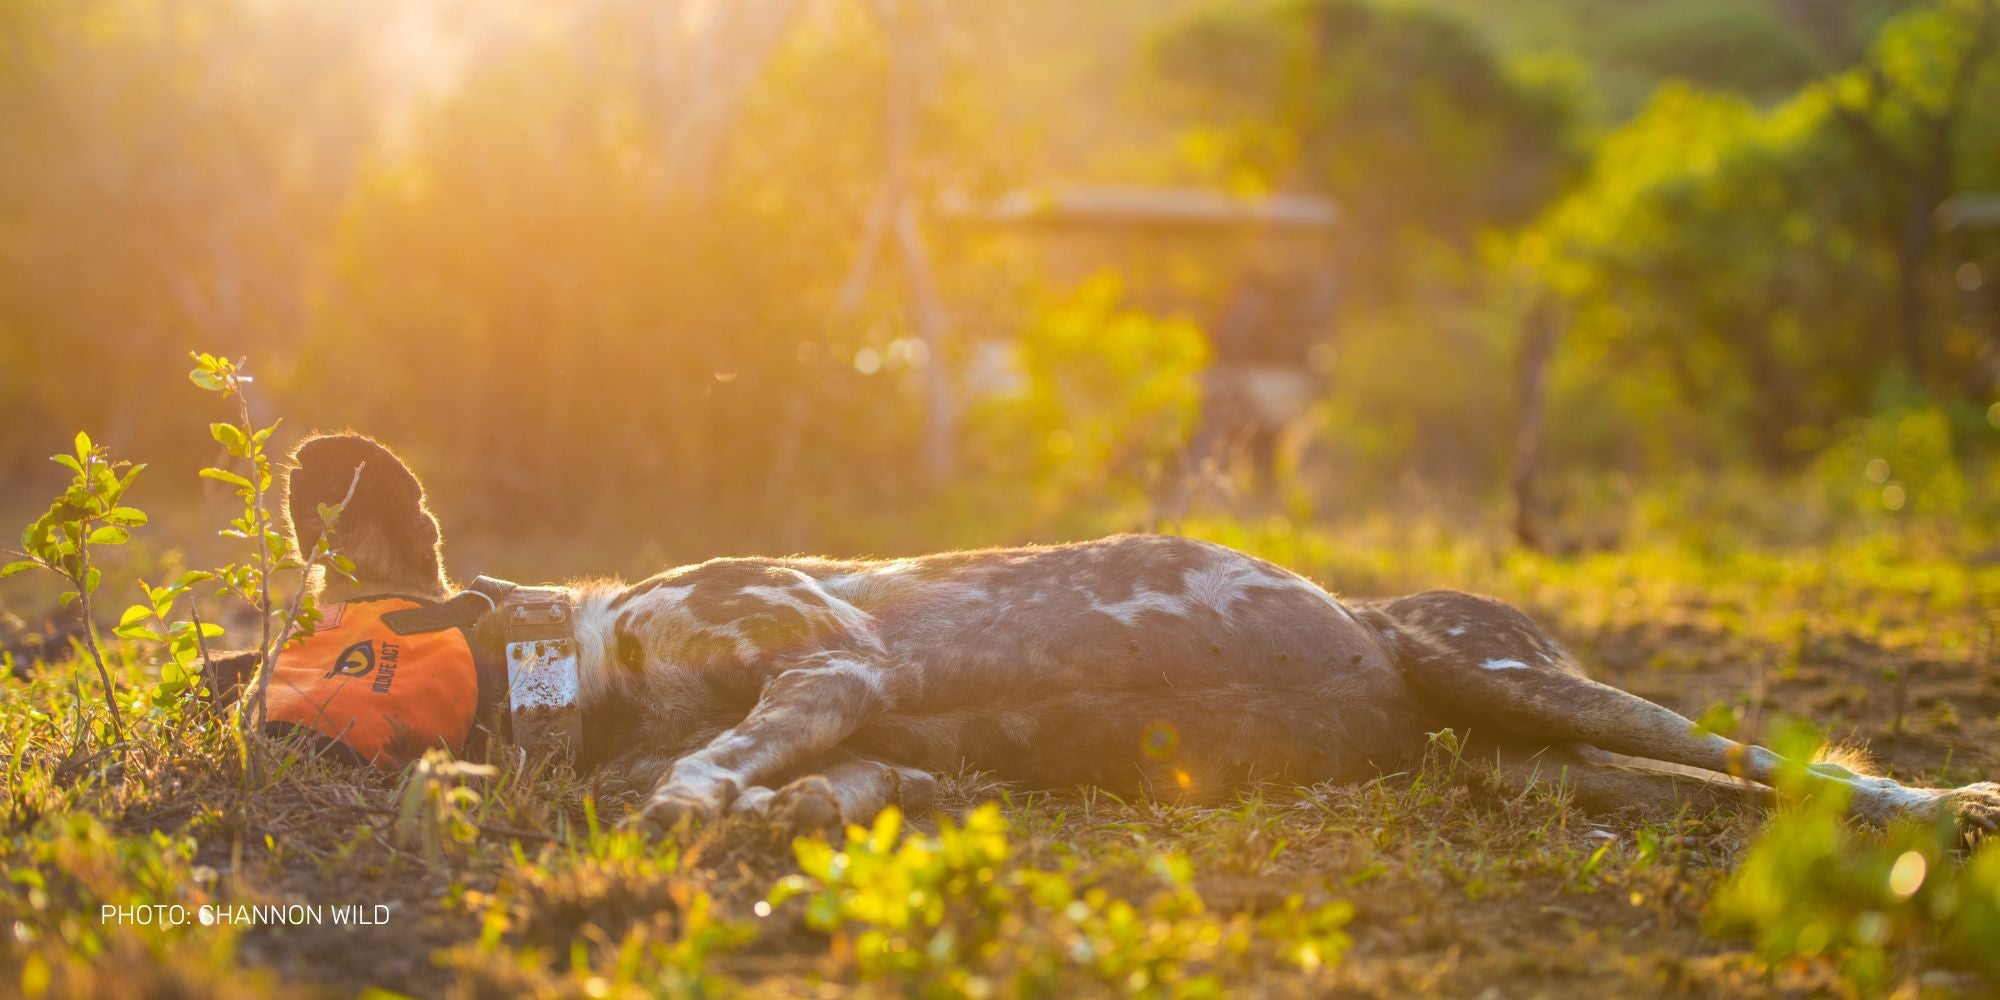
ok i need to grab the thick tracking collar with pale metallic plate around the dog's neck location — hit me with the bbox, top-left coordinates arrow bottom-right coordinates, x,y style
468,576 -> 584,760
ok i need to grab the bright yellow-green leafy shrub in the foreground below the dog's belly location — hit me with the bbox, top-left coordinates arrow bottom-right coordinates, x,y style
770,804 -> 1352,996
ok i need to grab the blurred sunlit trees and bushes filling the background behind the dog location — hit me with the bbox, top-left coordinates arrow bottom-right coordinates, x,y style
0,0 -> 2000,556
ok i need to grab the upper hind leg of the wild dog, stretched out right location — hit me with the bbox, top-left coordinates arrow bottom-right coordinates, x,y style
1368,590 -> 2000,832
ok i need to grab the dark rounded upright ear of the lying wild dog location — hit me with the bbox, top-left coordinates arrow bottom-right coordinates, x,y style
284,434 -> 446,598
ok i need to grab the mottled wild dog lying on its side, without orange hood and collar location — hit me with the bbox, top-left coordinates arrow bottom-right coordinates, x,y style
288,434 -> 2000,834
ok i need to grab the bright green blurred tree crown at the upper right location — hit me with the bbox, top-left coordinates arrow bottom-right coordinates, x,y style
1516,0 -> 2000,464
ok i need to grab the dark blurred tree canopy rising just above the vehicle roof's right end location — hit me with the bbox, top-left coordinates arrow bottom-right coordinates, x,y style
1156,0 -> 1582,290
